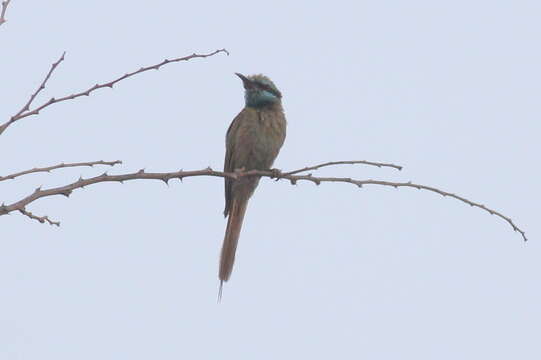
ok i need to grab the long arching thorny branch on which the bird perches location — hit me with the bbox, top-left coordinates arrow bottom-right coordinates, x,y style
0,161 -> 528,241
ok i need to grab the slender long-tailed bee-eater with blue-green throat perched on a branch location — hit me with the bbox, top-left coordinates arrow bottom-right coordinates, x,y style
218,73 -> 287,301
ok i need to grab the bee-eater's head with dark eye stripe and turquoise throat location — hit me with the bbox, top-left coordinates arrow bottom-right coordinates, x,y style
235,73 -> 282,108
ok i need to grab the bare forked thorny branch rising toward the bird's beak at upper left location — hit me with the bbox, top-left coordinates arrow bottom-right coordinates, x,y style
0,49 -> 229,135
